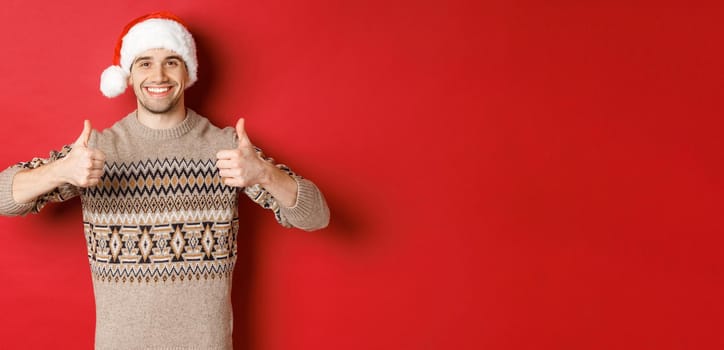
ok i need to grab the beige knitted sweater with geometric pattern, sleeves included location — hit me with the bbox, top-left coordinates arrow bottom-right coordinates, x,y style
0,110 -> 329,349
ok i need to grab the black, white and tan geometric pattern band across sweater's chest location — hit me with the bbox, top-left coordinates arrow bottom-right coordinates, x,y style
82,158 -> 238,283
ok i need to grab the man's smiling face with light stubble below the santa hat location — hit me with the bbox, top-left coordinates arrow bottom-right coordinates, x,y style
128,49 -> 189,114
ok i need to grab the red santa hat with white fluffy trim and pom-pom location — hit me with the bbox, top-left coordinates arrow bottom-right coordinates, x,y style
101,12 -> 199,98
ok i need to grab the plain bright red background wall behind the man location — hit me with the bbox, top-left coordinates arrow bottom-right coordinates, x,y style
0,0 -> 724,349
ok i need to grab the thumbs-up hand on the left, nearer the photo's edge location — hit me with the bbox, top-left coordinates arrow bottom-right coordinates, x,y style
58,120 -> 106,187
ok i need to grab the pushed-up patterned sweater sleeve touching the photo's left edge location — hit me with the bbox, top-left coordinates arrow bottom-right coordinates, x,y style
0,145 -> 80,216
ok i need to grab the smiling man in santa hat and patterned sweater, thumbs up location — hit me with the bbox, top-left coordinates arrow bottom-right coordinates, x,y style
0,13 -> 329,349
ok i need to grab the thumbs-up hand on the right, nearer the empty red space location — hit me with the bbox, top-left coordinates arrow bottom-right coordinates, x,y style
216,118 -> 270,187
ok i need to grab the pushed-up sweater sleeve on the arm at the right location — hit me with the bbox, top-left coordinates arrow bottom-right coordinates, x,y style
244,148 -> 329,231
